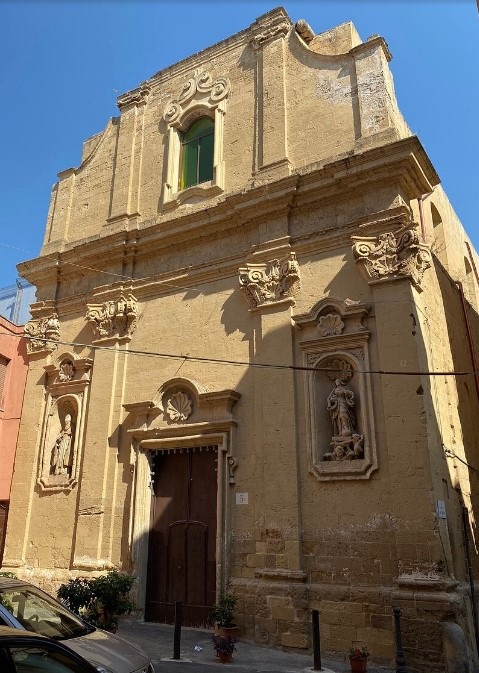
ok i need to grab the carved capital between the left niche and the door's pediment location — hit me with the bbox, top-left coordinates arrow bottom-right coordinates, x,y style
85,293 -> 140,339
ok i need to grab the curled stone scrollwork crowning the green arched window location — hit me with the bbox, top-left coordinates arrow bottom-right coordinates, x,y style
163,70 -> 231,125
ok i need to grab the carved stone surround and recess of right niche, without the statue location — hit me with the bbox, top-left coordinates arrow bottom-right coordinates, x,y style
293,299 -> 378,481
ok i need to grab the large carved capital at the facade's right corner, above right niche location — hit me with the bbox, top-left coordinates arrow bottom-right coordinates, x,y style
352,229 -> 431,288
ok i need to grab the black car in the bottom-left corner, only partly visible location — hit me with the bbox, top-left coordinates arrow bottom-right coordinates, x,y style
0,626 -> 98,673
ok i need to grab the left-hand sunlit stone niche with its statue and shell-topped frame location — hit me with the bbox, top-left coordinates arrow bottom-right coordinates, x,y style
37,353 -> 92,491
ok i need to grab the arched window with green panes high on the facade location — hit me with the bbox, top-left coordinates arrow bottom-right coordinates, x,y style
180,117 -> 215,189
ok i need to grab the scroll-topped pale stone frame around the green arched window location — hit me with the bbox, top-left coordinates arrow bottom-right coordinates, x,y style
163,71 -> 230,208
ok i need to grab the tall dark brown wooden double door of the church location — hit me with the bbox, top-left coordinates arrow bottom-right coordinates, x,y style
145,447 -> 218,626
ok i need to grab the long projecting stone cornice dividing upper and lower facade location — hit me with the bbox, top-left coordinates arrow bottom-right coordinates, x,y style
18,137 -> 438,301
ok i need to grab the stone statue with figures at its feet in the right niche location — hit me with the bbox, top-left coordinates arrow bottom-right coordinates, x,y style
323,361 -> 364,461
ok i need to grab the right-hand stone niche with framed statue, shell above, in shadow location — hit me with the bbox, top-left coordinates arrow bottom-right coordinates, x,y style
293,299 -> 377,481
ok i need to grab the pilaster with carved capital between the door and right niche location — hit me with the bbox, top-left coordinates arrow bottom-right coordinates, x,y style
240,241 -> 305,582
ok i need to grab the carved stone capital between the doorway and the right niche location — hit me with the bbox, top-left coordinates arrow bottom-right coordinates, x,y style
239,252 -> 300,308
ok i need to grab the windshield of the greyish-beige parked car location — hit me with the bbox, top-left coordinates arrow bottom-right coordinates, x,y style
0,586 -> 94,640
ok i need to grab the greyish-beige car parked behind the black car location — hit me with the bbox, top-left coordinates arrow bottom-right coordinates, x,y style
0,576 -> 154,673
